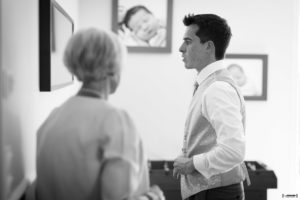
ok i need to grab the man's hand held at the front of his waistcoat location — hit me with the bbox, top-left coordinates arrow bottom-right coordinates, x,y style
173,156 -> 195,179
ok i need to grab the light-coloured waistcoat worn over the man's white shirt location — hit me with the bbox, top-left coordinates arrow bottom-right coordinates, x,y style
181,70 -> 249,199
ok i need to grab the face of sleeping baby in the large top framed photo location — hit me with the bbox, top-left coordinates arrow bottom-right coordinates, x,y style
128,9 -> 159,41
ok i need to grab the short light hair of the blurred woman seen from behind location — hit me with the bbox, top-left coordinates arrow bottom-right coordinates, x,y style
63,28 -> 125,82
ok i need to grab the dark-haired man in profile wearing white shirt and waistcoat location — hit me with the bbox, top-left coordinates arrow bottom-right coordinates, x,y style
173,14 -> 249,200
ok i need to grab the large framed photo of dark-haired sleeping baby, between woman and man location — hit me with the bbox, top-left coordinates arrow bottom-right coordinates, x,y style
112,0 -> 173,53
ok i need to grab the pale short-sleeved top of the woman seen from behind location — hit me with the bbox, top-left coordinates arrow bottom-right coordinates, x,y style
37,96 -> 149,200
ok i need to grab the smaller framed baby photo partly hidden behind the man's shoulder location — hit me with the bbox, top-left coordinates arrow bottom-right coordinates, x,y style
225,54 -> 268,101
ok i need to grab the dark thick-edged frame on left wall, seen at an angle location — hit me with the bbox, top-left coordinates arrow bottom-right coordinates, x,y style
39,0 -> 74,91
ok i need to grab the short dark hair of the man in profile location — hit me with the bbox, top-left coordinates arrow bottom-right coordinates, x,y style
183,14 -> 231,60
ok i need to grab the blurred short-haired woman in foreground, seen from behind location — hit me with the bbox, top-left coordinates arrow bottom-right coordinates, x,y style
36,29 -> 164,200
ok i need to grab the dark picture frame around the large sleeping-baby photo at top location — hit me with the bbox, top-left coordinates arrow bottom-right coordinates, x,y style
112,0 -> 173,53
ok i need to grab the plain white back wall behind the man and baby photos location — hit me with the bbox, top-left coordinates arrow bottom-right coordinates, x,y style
79,0 -> 300,200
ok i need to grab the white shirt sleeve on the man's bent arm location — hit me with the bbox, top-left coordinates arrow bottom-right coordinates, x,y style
193,81 -> 245,178
